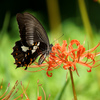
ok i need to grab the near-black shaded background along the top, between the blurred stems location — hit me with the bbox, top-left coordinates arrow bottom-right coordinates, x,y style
0,0 -> 100,30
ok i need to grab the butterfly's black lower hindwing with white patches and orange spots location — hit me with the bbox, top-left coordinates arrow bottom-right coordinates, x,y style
12,41 -> 46,68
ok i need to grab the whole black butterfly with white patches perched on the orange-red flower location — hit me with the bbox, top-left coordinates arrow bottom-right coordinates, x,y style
12,13 -> 53,69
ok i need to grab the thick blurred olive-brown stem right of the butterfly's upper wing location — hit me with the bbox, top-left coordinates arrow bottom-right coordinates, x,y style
46,0 -> 62,38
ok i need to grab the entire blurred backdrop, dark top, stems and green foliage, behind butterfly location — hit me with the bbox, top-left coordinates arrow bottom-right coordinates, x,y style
0,0 -> 100,100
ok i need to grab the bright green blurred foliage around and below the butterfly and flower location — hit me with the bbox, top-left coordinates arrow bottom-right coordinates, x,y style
0,10 -> 100,100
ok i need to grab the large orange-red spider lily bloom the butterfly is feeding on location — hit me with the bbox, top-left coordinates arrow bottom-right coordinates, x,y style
26,39 -> 100,77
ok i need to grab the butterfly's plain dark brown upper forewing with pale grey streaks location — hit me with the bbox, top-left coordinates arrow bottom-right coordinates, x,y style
17,13 -> 49,46
